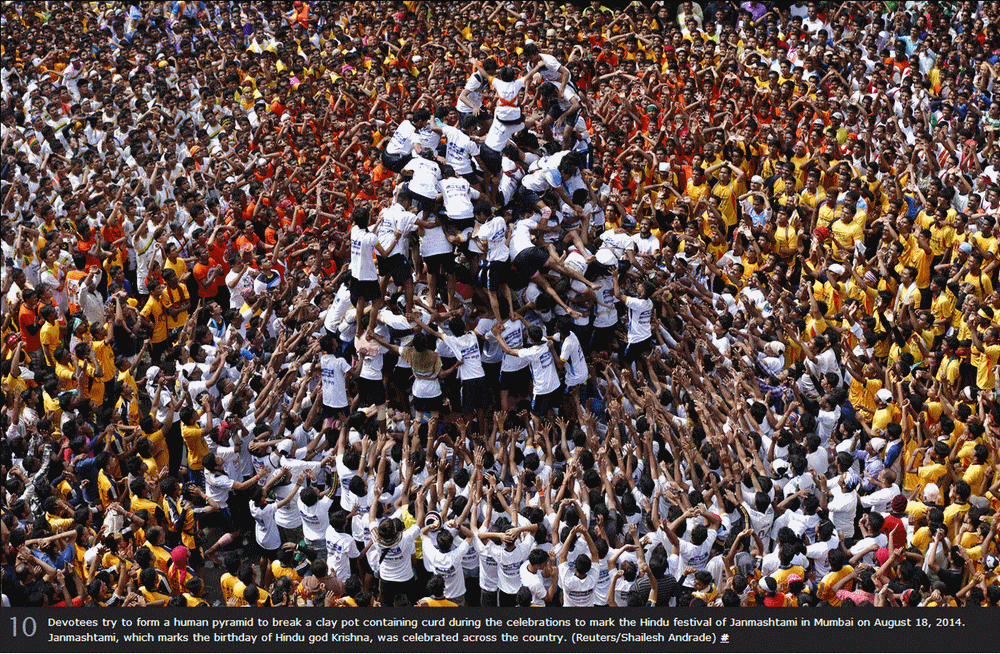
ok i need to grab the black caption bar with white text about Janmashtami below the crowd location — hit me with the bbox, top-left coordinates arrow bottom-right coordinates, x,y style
0,608 -> 1000,654
